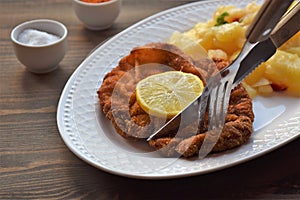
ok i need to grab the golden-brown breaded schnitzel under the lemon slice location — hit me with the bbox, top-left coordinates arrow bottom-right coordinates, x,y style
97,43 -> 254,157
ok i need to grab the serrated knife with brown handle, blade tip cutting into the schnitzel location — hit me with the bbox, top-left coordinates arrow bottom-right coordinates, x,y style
147,2 -> 300,141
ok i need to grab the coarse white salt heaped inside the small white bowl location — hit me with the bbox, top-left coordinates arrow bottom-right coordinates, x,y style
18,29 -> 59,46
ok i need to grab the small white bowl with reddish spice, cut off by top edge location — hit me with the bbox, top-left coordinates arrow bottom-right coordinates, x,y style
72,0 -> 121,30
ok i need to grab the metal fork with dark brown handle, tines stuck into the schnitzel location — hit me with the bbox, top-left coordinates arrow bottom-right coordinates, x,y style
198,0 -> 292,158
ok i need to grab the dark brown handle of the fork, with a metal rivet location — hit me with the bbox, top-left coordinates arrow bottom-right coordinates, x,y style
246,0 -> 293,43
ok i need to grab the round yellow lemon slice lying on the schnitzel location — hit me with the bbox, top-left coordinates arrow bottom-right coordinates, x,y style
136,71 -> 204,118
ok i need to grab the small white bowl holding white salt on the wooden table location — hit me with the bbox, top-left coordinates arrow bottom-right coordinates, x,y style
10,19 -> 68,74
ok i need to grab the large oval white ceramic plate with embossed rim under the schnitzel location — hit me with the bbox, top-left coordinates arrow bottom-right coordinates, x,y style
57,0 -> 300,179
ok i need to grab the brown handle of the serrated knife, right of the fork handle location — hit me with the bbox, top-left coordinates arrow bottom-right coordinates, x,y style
271,1 -> 300,48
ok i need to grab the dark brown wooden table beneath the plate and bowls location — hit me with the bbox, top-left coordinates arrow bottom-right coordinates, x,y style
0,0 -> 300,199
